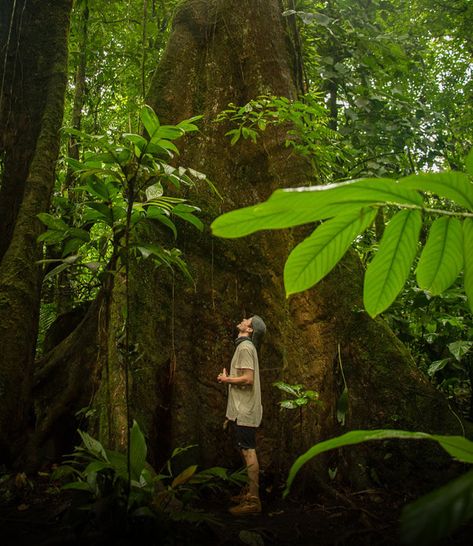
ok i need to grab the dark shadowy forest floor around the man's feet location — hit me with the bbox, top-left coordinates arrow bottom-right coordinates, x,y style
0,468 -> 473,546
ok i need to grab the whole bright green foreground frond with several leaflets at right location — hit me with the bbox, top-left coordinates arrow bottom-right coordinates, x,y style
212,160 -> 473,316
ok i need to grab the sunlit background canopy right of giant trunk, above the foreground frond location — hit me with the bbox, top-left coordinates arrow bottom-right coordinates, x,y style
285,0 -> 473,175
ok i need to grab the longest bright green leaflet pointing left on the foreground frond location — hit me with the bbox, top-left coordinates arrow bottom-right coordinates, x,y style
211,178 -> 423,238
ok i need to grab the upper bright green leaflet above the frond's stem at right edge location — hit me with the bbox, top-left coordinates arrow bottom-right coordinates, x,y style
399,172 -> 473,211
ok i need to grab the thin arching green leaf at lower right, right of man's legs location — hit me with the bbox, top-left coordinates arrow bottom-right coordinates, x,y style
284,429 -> 473,496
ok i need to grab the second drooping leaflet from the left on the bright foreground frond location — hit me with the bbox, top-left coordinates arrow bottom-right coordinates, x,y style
363,210 -> 422,317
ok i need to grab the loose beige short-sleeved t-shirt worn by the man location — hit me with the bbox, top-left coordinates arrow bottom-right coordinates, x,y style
227,340 -> 263,427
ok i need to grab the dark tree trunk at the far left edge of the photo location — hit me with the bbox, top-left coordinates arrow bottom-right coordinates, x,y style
0,0 -> 72,460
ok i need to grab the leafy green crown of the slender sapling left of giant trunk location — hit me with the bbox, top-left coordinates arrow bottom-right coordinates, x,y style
38,106 -> 207,286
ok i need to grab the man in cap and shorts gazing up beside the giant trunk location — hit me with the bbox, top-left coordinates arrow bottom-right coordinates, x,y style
217,315 -> 266,516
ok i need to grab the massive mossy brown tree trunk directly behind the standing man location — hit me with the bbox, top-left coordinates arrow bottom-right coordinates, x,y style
32,0 -> 460,484
